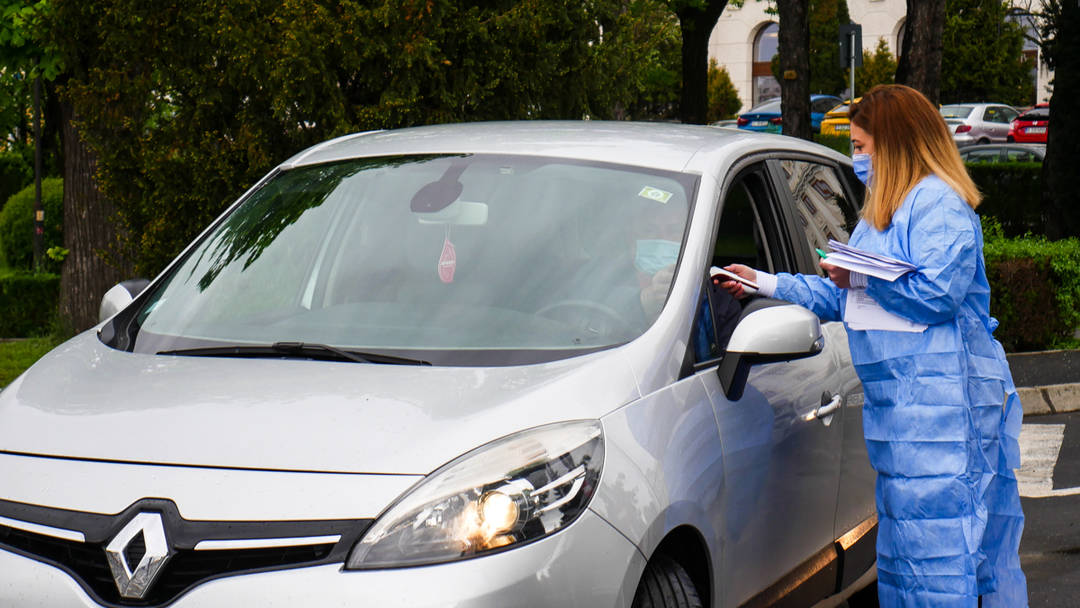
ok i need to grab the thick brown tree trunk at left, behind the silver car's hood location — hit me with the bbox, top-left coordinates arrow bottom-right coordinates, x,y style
59,103 -> 131,332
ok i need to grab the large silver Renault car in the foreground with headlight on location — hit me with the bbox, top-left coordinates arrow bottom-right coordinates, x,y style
0,122 -> 876,608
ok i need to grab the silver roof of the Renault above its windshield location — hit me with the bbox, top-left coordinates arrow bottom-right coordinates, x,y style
280,121 -> 847,173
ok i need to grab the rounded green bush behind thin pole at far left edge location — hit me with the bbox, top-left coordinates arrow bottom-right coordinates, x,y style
0,177 -> 64,272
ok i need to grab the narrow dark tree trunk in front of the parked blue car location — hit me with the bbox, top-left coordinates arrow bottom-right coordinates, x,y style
777,0 -> 813,141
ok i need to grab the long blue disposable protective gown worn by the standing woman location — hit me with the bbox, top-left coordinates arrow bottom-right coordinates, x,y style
774,176 -> 1027,608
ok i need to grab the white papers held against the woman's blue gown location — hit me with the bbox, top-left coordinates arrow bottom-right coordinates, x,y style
825,241 -> 927,333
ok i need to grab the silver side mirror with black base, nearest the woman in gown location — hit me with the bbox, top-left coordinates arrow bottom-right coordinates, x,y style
717,305 -> 825,401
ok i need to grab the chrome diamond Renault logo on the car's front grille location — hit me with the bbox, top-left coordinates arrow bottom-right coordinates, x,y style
105,512 -> 172,599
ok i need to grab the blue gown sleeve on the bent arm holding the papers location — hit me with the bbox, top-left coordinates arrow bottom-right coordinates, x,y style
866,190 -> 978,325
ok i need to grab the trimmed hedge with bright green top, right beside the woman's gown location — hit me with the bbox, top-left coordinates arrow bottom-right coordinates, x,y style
983,218 -> 1080,352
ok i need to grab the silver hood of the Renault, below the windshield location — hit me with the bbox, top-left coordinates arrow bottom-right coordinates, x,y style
0,333 -> 637,474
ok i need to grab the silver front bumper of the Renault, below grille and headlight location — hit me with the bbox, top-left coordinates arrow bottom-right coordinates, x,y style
0,511 -> 645,608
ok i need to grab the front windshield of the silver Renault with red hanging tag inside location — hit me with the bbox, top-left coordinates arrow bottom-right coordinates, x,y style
124,154 -> 698,365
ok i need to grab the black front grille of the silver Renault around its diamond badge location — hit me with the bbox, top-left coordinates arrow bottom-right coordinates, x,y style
0,501 -> 370,607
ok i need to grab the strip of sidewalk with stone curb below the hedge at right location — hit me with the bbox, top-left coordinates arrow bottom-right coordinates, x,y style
1008,351 -> 1080,416
